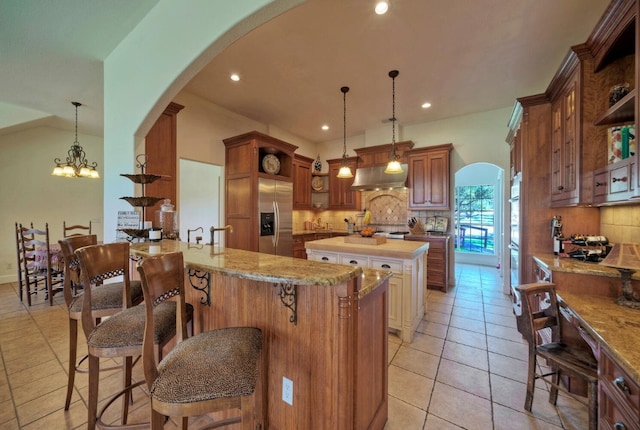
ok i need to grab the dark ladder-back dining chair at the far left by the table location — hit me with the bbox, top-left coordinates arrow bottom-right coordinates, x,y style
19,223 -> 64,306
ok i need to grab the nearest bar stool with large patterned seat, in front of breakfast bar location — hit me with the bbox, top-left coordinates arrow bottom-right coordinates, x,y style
138,252 -> 266,430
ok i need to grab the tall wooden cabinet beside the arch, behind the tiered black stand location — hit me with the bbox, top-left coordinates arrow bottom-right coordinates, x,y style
144,102 -> 184,221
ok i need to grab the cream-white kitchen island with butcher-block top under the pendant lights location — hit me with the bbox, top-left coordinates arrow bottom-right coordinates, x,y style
305,235 -> 429,342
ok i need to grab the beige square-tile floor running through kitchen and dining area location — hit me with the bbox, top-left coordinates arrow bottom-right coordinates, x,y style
0,265 -> 587,430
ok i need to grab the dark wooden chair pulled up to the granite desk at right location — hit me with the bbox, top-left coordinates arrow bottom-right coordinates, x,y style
516,283 -> 598,430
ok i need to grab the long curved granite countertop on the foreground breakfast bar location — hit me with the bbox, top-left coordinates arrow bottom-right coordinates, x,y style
131,240 -> 392,297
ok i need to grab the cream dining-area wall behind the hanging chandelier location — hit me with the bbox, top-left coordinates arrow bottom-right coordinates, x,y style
0,127 -> 103,283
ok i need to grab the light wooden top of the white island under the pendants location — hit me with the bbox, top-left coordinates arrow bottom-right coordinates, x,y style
305,235 -> 429,259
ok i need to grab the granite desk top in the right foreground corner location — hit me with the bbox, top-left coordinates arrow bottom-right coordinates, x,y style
557,291 -> 640,383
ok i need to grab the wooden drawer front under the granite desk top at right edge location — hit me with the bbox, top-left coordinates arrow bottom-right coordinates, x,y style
598,349 -> 640,422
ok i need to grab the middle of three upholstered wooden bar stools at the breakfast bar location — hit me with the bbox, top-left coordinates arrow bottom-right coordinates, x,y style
75,242 -> 188,430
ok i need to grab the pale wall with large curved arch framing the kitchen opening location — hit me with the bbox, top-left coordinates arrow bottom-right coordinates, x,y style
104,0 -> 301,241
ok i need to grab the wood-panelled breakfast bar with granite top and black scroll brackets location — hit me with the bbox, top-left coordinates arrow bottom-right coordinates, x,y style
131,241 -> 392,429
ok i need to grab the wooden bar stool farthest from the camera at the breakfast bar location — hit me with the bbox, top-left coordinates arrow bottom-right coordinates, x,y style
59,235 -> 142,411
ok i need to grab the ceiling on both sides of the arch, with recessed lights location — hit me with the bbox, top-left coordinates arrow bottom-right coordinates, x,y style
0,0 -> 609,142
